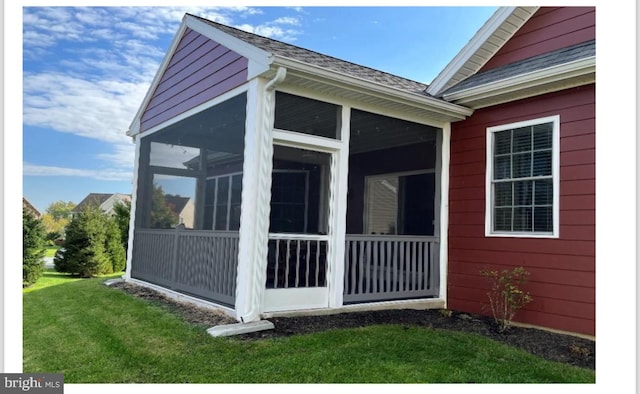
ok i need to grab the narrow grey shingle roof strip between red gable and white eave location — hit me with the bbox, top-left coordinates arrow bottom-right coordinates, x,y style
442,40 -> 596,95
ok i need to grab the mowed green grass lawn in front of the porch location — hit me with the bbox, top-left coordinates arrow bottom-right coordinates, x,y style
23,271 -> 595,383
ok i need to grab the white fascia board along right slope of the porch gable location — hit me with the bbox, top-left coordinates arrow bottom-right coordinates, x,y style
185,15 -> 273,79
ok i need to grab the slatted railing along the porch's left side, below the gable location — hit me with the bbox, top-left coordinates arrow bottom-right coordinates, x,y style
131,229 -> 239,307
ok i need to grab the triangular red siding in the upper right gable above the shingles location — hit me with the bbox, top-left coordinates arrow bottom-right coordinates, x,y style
480,7 -> 596,72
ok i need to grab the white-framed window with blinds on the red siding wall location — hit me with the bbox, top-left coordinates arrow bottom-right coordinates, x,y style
486,116 -> 560,238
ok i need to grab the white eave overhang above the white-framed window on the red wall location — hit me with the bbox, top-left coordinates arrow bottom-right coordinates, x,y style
443,56 -> 596,109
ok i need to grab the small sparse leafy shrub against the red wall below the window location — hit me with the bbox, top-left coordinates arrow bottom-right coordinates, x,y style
480,267 -> 533,332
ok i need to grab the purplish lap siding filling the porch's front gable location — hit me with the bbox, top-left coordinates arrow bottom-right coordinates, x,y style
141,29 -> 248,131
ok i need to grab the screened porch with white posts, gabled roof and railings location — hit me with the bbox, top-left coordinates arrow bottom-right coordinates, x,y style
126,15 -> 470,322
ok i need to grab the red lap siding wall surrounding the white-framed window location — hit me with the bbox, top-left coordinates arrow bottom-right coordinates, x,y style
447,85 -> 595,335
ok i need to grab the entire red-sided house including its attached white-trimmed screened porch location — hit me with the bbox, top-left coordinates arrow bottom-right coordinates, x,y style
125,7 -> 595,335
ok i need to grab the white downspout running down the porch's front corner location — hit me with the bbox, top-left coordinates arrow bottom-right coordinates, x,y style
240,67 -> 287,323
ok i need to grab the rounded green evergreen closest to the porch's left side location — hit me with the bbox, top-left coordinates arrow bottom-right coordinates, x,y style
53,207 -> 125,277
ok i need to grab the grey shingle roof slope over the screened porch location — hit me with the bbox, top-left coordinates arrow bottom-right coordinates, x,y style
190,14 -> 430,96
